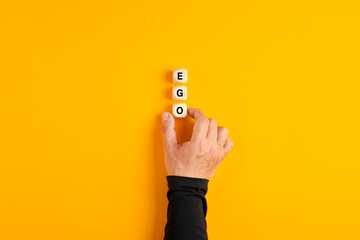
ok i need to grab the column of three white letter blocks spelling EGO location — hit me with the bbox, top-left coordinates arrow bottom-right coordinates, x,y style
172,69 -> 187,118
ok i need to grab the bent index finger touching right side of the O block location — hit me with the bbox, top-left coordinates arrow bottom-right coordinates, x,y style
188,108 -> 209,141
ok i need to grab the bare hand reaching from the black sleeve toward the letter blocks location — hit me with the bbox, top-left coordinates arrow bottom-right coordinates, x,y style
162,108 -> 234,179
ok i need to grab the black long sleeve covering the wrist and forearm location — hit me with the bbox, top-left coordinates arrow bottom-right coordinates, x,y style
164,176 -> 209,240
